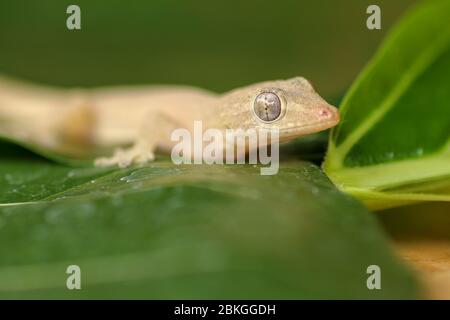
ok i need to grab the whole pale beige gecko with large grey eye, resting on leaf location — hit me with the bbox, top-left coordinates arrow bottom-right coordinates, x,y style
0,77 -> 339,167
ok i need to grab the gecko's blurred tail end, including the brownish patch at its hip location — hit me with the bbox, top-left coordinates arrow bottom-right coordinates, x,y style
0,74 -> 96,152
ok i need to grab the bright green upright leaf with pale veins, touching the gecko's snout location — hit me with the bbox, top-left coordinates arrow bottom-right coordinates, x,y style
324,0 -> 450,208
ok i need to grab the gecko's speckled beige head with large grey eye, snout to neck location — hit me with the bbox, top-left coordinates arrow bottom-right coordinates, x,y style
222,77 -> 339,140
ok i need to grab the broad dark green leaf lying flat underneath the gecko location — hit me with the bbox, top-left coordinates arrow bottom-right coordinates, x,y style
0,152 -> 419,299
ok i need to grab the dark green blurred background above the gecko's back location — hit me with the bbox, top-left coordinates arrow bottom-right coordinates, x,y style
0,0 -> 416,98
